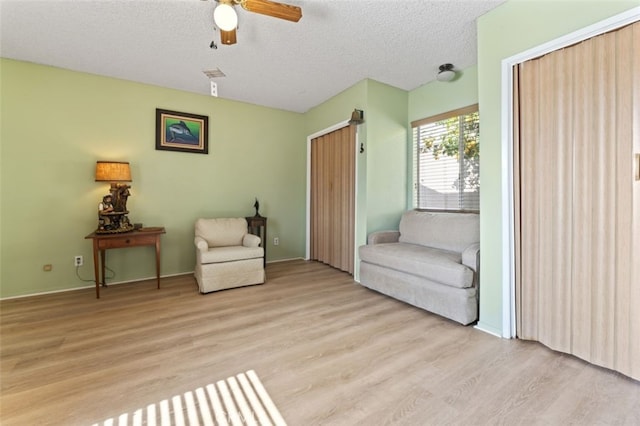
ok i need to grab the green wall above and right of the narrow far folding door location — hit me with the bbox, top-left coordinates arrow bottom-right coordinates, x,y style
306,79 -> 409,236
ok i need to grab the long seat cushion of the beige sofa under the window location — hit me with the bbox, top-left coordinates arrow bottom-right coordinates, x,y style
359,243 -> 473,288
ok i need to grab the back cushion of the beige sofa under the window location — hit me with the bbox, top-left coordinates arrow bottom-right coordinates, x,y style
399,210 -> 480,253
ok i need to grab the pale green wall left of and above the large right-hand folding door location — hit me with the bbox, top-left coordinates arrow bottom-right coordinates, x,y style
478,0 -> 640,335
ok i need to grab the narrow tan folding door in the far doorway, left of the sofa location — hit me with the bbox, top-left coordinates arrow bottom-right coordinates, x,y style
310,126 -> 356,274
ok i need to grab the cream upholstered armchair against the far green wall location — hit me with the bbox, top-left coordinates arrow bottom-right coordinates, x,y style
194,217 -> 265,293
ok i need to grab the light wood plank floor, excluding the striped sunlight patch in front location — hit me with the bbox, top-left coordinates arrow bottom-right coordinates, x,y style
0,260 -> 640,426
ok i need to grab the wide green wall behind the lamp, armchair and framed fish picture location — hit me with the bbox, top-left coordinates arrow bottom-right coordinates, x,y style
0,59 -> 306,297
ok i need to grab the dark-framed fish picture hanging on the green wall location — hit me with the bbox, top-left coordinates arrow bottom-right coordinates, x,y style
156,108 -> 209,154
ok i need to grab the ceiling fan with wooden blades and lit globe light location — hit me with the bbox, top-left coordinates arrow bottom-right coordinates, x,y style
213,0 -> 302,45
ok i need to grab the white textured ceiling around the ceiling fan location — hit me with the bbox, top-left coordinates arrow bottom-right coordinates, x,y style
0,0 -> 504,112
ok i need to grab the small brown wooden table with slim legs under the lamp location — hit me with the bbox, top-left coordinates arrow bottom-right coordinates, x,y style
84,227 -> 166,299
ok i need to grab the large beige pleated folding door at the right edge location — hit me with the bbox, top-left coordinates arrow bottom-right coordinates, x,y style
514,22 -> 640,380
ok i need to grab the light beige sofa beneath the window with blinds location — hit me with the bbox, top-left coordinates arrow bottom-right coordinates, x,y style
359,210 -> 480,325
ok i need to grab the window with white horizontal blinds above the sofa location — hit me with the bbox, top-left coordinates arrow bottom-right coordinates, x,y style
411,104 -> 480,211
